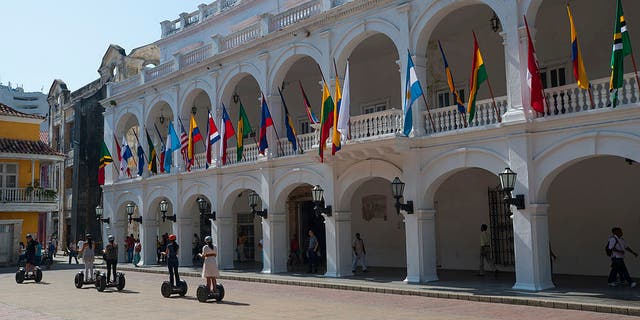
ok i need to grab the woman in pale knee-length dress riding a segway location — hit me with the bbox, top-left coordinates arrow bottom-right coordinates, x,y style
196,236 -> 224,302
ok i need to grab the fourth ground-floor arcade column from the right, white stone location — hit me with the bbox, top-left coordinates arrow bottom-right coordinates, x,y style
257,212 -> 288,273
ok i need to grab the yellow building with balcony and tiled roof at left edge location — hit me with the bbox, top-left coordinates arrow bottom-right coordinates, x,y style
0,103 -> 64,265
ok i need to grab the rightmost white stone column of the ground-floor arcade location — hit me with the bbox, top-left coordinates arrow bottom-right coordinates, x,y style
511,204 -> 554,291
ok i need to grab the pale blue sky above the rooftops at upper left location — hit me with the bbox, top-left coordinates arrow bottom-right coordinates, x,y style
0,0 -> 204,93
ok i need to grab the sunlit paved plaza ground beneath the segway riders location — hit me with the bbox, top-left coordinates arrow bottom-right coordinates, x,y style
0,270 -> 632,320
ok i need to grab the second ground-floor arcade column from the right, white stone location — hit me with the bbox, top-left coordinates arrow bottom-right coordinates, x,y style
404,209 -> 438,283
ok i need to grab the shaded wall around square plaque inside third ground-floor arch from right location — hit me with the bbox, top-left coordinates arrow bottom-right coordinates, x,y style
351,178 -> 407,267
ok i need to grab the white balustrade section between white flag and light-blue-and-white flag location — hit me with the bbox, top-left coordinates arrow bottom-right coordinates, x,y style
350,109 -> 402,140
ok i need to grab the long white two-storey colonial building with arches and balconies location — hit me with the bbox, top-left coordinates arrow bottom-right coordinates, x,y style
102,0 -> 640,290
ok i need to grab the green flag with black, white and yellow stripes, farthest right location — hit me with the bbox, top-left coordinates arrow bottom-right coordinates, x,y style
609,0 -> 631,108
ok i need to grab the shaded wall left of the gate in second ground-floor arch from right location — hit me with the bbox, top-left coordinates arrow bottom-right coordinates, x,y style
436,168 -> 500,270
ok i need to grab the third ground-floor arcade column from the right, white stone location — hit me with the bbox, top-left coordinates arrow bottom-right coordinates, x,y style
324,211 -> 353,277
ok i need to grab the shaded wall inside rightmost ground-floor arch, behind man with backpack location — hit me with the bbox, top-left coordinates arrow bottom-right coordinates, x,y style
549,157 -> 640,276
